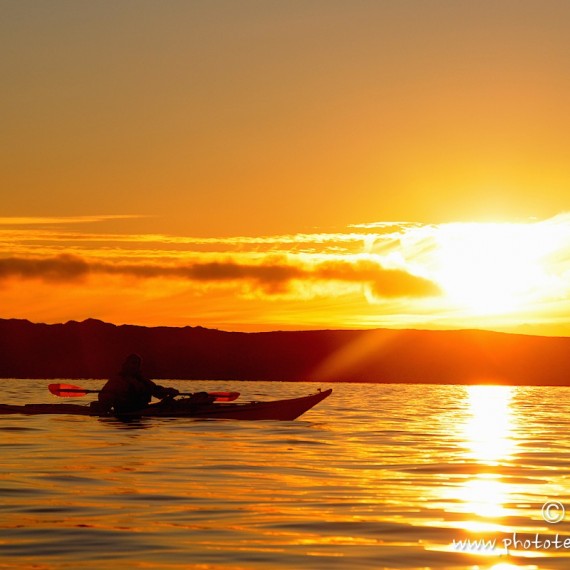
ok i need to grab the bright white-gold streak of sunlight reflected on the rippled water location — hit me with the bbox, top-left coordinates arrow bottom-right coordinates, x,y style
428,386 -> 562,570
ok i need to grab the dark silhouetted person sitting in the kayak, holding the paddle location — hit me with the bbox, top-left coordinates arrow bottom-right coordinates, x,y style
93,354 -> 179,414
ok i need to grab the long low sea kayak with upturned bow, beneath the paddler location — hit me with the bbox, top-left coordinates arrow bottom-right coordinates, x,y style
0,388 -> 332,420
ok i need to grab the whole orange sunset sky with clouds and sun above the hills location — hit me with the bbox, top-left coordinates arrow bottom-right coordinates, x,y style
0,0 -> 570,335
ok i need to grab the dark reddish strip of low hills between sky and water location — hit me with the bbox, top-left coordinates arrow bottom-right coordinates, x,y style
0,319 -> 570,386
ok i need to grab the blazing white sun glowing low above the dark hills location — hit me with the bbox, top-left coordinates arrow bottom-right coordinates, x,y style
433,223 -> 553,315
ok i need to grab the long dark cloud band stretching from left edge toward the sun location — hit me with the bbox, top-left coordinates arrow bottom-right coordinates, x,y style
0,254 -> 439,297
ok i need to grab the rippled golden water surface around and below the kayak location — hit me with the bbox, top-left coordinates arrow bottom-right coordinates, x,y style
0,380 -> 570,570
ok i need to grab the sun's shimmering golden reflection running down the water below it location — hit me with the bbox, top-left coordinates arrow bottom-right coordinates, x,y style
424,385 -> 568,570
